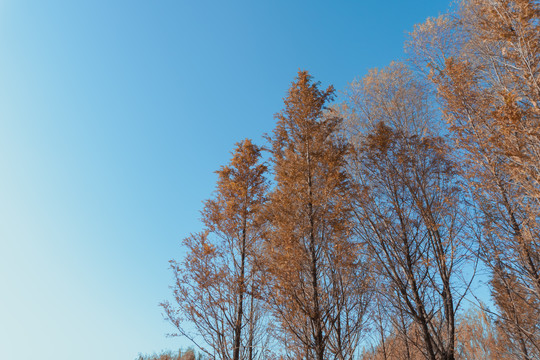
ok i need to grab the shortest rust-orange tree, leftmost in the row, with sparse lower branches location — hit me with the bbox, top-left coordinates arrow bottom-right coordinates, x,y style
163,140 -> 267,360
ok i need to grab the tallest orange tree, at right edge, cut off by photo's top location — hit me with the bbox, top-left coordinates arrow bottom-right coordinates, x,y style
410,0 -> 540,359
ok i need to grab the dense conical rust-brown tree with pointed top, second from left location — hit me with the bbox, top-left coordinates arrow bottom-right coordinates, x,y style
265,71 -> 367,360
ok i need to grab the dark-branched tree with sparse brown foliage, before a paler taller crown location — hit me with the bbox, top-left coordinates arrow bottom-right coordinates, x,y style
357,123 -> 462,360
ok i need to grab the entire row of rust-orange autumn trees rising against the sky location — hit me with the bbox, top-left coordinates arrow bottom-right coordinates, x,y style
163,0 -> 540,360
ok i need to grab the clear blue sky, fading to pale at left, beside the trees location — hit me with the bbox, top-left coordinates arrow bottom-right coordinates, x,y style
0,0 -> 449,360
